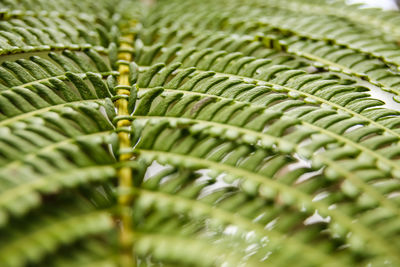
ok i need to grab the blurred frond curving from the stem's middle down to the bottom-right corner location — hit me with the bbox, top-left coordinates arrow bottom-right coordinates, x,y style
130,125 -> 395,266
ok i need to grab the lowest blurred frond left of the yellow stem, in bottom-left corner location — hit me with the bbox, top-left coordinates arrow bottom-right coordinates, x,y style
0,197 -> 112,267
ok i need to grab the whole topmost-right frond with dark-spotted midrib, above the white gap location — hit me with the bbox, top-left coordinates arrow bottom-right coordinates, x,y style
146,1 -> 400,99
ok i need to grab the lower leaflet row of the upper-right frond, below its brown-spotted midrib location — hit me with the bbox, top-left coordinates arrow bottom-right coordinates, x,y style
145,2 -> 399,99
